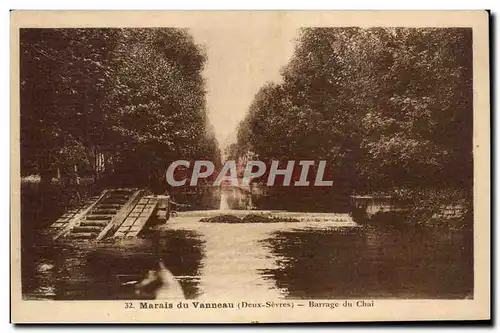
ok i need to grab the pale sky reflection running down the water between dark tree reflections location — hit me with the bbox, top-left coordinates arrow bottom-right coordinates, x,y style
167,216 -> 285,300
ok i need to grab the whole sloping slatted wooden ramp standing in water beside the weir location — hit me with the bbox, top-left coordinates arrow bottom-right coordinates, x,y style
48,188 -> 169,242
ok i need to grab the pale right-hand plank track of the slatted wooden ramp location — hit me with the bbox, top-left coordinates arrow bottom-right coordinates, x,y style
114,196 -> 160,238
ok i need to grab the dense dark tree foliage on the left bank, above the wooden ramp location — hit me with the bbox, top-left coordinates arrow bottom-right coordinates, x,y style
20,28 -> 218,189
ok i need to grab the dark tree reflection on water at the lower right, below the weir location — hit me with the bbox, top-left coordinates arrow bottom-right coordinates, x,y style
266,228 -> 473,299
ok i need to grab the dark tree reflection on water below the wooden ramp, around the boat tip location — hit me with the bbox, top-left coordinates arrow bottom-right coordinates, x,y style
22,230 -> 202,300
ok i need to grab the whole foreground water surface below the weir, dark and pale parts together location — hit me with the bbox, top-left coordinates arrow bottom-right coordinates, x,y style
22,211 -> 473,300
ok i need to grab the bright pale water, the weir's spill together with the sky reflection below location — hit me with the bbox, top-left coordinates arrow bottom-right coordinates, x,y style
162,210 -> 356,300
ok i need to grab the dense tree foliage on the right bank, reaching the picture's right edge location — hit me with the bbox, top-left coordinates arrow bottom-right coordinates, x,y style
230,28 -> 473,198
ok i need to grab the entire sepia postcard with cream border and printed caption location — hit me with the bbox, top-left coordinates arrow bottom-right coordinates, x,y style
11,11 -> 490,323
